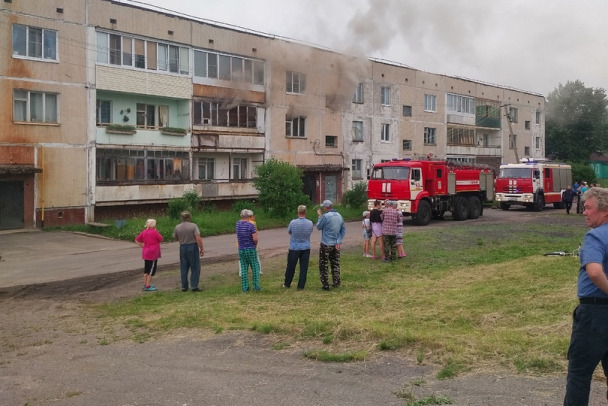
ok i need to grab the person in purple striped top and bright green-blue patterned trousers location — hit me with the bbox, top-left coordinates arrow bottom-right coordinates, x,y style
236,209 -> 262,292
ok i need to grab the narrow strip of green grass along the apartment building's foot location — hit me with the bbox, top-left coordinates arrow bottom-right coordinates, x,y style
45,206 -> 366,241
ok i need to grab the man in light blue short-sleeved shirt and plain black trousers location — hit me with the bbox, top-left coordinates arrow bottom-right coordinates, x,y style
283,205 -> 313,290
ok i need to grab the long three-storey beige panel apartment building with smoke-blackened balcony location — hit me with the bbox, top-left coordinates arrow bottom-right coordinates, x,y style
0,0 -> 545,230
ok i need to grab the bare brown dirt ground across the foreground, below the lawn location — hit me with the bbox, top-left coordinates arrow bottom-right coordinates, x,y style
0,211 -> 606,406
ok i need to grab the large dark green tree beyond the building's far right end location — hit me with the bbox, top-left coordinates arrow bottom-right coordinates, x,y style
546,80 -> 608,162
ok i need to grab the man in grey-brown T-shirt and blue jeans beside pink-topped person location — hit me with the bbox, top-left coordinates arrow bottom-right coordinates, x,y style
173,211 -> 204,292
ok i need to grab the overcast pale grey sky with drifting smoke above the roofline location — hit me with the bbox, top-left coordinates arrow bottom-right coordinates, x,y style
132,0 -> 608,96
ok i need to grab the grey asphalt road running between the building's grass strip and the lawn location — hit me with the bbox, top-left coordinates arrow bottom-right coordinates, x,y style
0,208 -> 553,287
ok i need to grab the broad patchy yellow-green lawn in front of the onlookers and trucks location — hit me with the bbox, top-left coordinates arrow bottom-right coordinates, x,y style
92,213 -> 586,378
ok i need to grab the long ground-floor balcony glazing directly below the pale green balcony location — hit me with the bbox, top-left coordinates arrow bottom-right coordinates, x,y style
96,148 -> 190,184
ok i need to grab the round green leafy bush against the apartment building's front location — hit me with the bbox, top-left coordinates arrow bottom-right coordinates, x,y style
253,158 -> 310,217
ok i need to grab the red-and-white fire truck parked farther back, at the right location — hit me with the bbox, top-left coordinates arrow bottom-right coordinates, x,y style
496,158 -> 572,210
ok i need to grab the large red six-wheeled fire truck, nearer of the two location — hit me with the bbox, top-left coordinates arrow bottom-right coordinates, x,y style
367,158 -> 494,226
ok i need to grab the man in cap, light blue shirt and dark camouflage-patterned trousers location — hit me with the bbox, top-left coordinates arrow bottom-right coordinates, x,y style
317,200 -> 346,290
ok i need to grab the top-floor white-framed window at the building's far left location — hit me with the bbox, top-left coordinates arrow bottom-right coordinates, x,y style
13,24 -> 57,61
